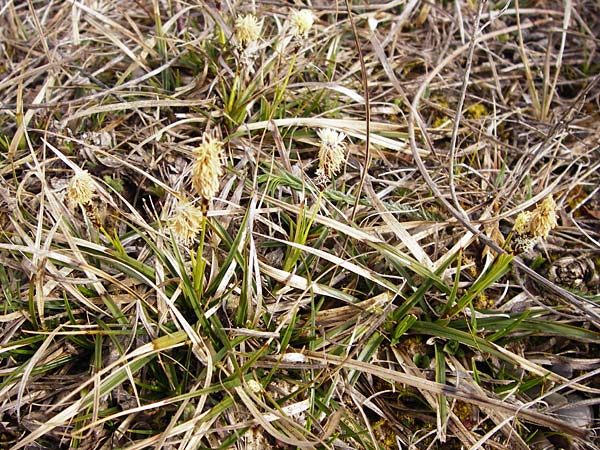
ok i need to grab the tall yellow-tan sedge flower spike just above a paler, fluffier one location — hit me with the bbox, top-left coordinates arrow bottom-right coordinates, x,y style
192,134 -> 223,202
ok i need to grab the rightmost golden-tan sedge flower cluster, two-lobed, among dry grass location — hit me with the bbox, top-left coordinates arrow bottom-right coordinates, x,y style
513,195 -> 558,253
